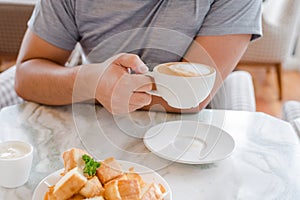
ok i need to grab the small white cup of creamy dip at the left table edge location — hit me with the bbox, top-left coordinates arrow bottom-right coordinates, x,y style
0,141 -> 33,188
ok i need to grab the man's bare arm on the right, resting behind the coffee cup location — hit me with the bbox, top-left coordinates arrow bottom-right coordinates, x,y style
144,34 -> 251,113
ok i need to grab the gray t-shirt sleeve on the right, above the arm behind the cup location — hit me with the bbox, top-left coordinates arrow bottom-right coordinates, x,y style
198,0 -> 262,40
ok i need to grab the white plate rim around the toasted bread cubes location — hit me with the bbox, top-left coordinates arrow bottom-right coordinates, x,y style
32,160 -> 172,200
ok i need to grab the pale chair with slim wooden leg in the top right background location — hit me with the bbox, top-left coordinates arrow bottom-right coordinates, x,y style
239,0 -> 300,99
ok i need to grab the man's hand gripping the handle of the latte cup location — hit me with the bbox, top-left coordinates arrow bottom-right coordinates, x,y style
95,54 -> 152,114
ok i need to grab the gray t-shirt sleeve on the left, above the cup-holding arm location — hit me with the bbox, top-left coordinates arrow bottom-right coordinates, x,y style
28,0 -> 79,50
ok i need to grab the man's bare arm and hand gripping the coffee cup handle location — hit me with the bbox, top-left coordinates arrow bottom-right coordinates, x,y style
15,30 -> 152,114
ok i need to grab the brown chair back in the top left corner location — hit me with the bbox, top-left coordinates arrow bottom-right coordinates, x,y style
0,3 -> 34,72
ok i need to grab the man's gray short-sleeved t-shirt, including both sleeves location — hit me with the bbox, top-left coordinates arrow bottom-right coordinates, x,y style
28,0 -> 262,67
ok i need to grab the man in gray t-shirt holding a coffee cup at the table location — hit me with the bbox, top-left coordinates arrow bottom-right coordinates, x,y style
15,0 -> 261,114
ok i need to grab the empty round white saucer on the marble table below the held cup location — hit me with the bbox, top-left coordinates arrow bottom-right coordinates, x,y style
144,120 -> 235,164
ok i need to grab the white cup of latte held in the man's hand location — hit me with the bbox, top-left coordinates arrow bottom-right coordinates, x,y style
147,62 -> 216,109
